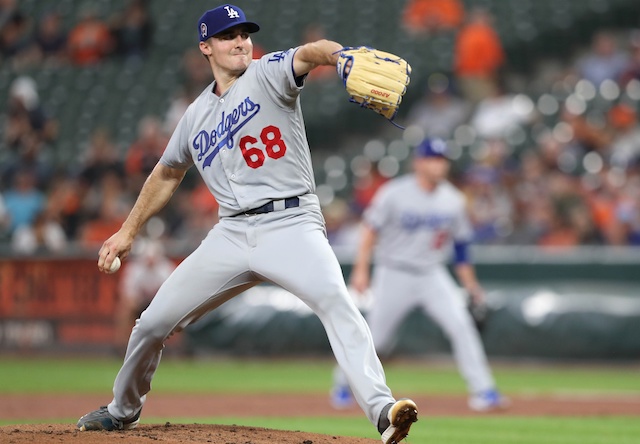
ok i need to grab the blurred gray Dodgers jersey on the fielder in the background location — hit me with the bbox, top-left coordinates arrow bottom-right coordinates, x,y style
364,174 -> 473,270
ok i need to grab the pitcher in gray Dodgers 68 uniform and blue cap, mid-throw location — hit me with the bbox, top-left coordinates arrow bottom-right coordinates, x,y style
77,5 -> 417,444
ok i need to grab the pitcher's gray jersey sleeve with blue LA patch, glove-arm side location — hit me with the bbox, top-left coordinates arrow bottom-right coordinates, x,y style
257,48 -> 305,105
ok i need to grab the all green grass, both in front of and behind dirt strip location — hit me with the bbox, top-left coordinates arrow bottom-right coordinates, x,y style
0,357 -> 640,444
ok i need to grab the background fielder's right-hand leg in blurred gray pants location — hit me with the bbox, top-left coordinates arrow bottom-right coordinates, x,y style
426,269 -> 495,393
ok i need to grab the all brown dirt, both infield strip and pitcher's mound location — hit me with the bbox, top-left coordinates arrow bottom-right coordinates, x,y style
0,394 -> 640,444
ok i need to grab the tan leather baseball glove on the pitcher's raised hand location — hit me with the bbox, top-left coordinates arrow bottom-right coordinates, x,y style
336,46 -> 411,126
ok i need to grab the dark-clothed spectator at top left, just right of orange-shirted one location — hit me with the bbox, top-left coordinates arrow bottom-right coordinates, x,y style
111,0 -> 153,60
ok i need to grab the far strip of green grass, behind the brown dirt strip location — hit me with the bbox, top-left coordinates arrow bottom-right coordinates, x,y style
0,358 -> 640,395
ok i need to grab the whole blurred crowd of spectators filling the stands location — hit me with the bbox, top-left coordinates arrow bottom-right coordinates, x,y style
0,0 -> 640,254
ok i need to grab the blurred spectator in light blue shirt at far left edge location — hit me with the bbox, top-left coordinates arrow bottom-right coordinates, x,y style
4,170 -> 46,234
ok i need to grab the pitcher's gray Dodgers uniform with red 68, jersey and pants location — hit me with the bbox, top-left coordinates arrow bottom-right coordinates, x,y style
108,49 -> 394,425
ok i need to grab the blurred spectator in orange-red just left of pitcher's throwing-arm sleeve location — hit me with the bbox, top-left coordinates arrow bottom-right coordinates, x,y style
125,116 -> 169,190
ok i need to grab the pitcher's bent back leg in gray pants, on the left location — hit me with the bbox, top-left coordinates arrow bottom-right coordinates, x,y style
108,225 -> 257,419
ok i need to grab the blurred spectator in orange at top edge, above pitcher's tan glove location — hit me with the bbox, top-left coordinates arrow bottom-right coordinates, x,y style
402,0 -> 464,34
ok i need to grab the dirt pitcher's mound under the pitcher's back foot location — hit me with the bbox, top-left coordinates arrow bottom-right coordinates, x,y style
0,423 -> 379,444
